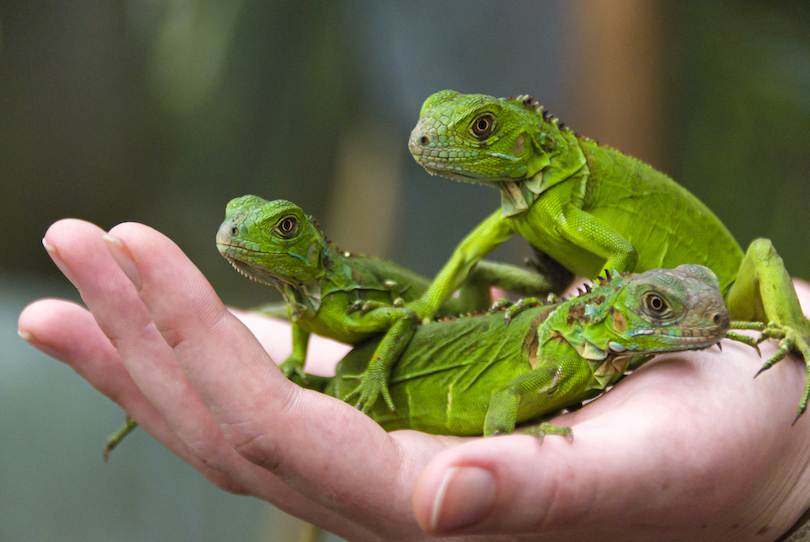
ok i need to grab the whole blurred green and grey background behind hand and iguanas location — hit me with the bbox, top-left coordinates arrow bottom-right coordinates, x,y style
0,0 -> 810,541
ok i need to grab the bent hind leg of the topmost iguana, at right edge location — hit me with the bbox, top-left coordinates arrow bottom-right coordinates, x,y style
726,239 -> 810,423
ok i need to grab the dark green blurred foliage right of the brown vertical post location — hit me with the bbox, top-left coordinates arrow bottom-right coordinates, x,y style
666,1 -> 810,279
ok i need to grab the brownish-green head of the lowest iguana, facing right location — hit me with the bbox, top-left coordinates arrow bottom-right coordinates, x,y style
582,264 -> 730,355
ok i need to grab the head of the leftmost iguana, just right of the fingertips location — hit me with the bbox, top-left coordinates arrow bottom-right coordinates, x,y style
217,196 -> 324,288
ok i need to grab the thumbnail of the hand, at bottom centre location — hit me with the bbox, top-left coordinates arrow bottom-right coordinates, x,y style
430,467 -> 495,532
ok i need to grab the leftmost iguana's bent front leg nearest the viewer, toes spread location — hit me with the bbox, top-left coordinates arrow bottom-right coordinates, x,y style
343,300 -> 419,414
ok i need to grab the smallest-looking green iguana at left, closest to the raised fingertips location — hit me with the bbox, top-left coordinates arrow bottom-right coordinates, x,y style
104,196 -> 551,460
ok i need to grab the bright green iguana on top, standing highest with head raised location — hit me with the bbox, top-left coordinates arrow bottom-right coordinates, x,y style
407,90 -> 810,423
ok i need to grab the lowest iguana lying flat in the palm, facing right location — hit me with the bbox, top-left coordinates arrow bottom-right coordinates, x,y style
302,265 -> 729,438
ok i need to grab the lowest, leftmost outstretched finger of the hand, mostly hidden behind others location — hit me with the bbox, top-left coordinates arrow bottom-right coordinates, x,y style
18,299 -> 244,493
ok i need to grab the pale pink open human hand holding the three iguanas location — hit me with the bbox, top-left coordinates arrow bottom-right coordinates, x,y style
19,220 -> 810,541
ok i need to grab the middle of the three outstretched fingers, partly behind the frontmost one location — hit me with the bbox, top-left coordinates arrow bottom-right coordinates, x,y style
40,220 -> 358,533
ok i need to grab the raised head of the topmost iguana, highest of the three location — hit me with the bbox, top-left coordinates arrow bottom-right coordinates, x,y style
408,90 -> 585,214
